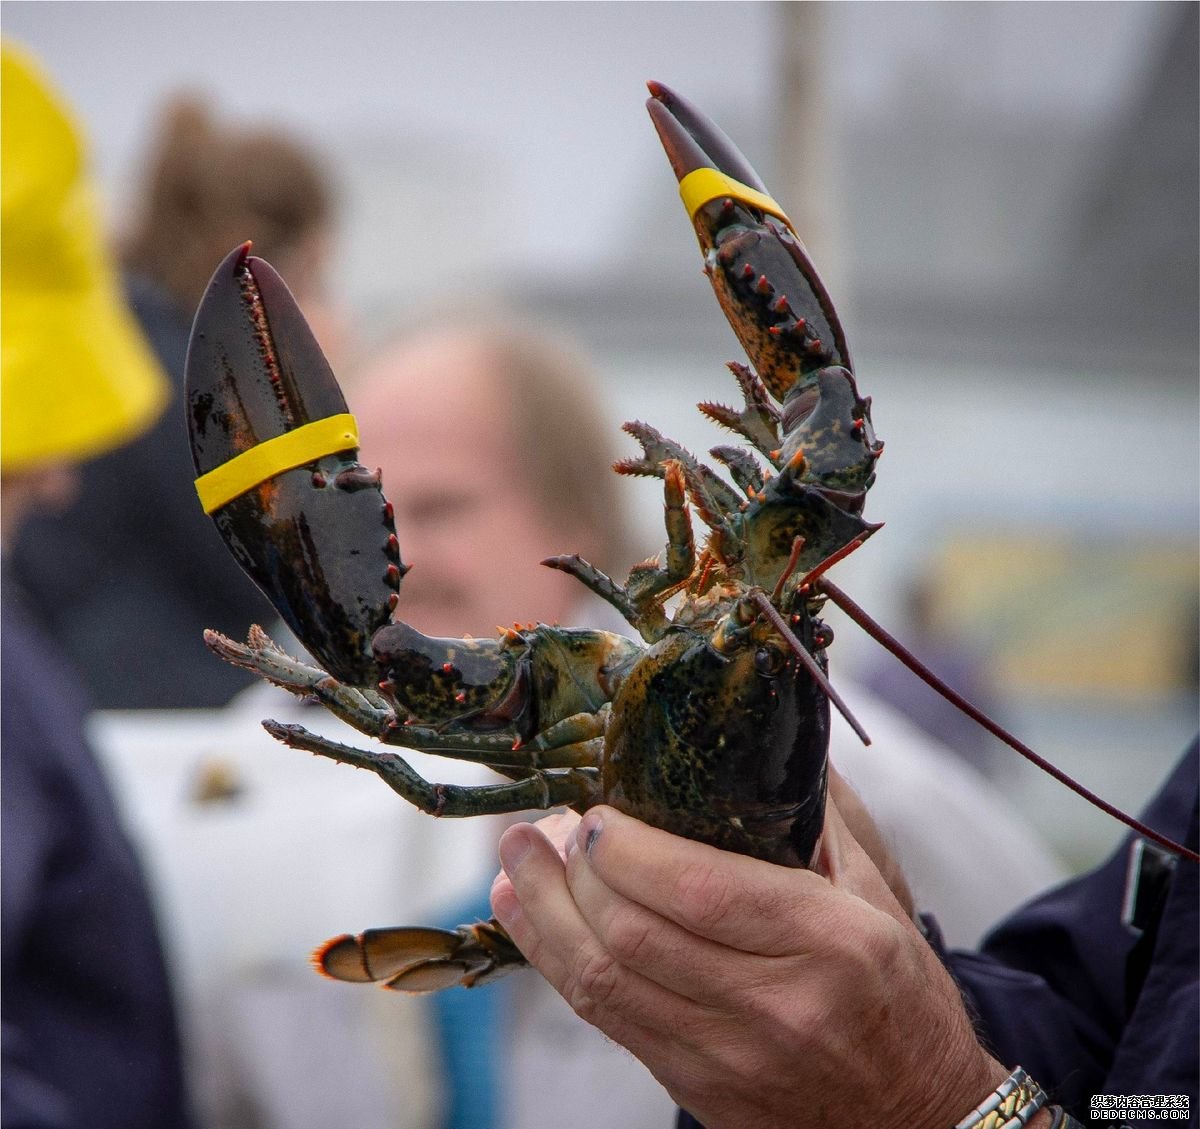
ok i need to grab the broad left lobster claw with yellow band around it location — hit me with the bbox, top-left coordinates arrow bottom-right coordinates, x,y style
186,244 -> 407,686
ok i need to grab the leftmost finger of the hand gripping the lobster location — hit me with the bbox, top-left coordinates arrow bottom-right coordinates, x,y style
492,823 -> 696,1053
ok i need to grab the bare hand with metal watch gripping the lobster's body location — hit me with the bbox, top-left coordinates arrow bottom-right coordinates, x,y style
492,801 -> 1008,1129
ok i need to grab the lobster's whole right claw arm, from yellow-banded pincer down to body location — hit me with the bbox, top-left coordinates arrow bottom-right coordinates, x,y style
646,82 -> 883,568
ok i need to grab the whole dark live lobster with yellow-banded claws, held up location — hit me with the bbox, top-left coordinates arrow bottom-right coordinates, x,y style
186,83 -> 1195,991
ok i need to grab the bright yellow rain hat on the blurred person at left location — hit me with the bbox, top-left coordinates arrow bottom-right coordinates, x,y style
0,44 -> 168,473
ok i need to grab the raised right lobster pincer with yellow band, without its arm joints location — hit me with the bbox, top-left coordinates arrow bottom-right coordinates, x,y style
646,82 -> 851,401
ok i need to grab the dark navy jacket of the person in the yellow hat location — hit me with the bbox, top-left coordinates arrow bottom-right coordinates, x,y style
0,584 -> 192,1129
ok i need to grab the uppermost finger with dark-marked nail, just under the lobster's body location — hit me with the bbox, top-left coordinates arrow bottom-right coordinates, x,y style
576,807 -> 830,956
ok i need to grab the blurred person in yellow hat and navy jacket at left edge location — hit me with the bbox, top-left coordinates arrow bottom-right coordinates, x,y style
0,46 -> 191,1129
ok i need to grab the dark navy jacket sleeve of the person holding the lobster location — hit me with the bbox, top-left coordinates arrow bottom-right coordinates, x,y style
947,745 -> 1200,1118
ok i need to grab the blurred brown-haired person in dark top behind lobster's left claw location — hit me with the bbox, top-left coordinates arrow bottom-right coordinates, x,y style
13,90 -> 337,709
